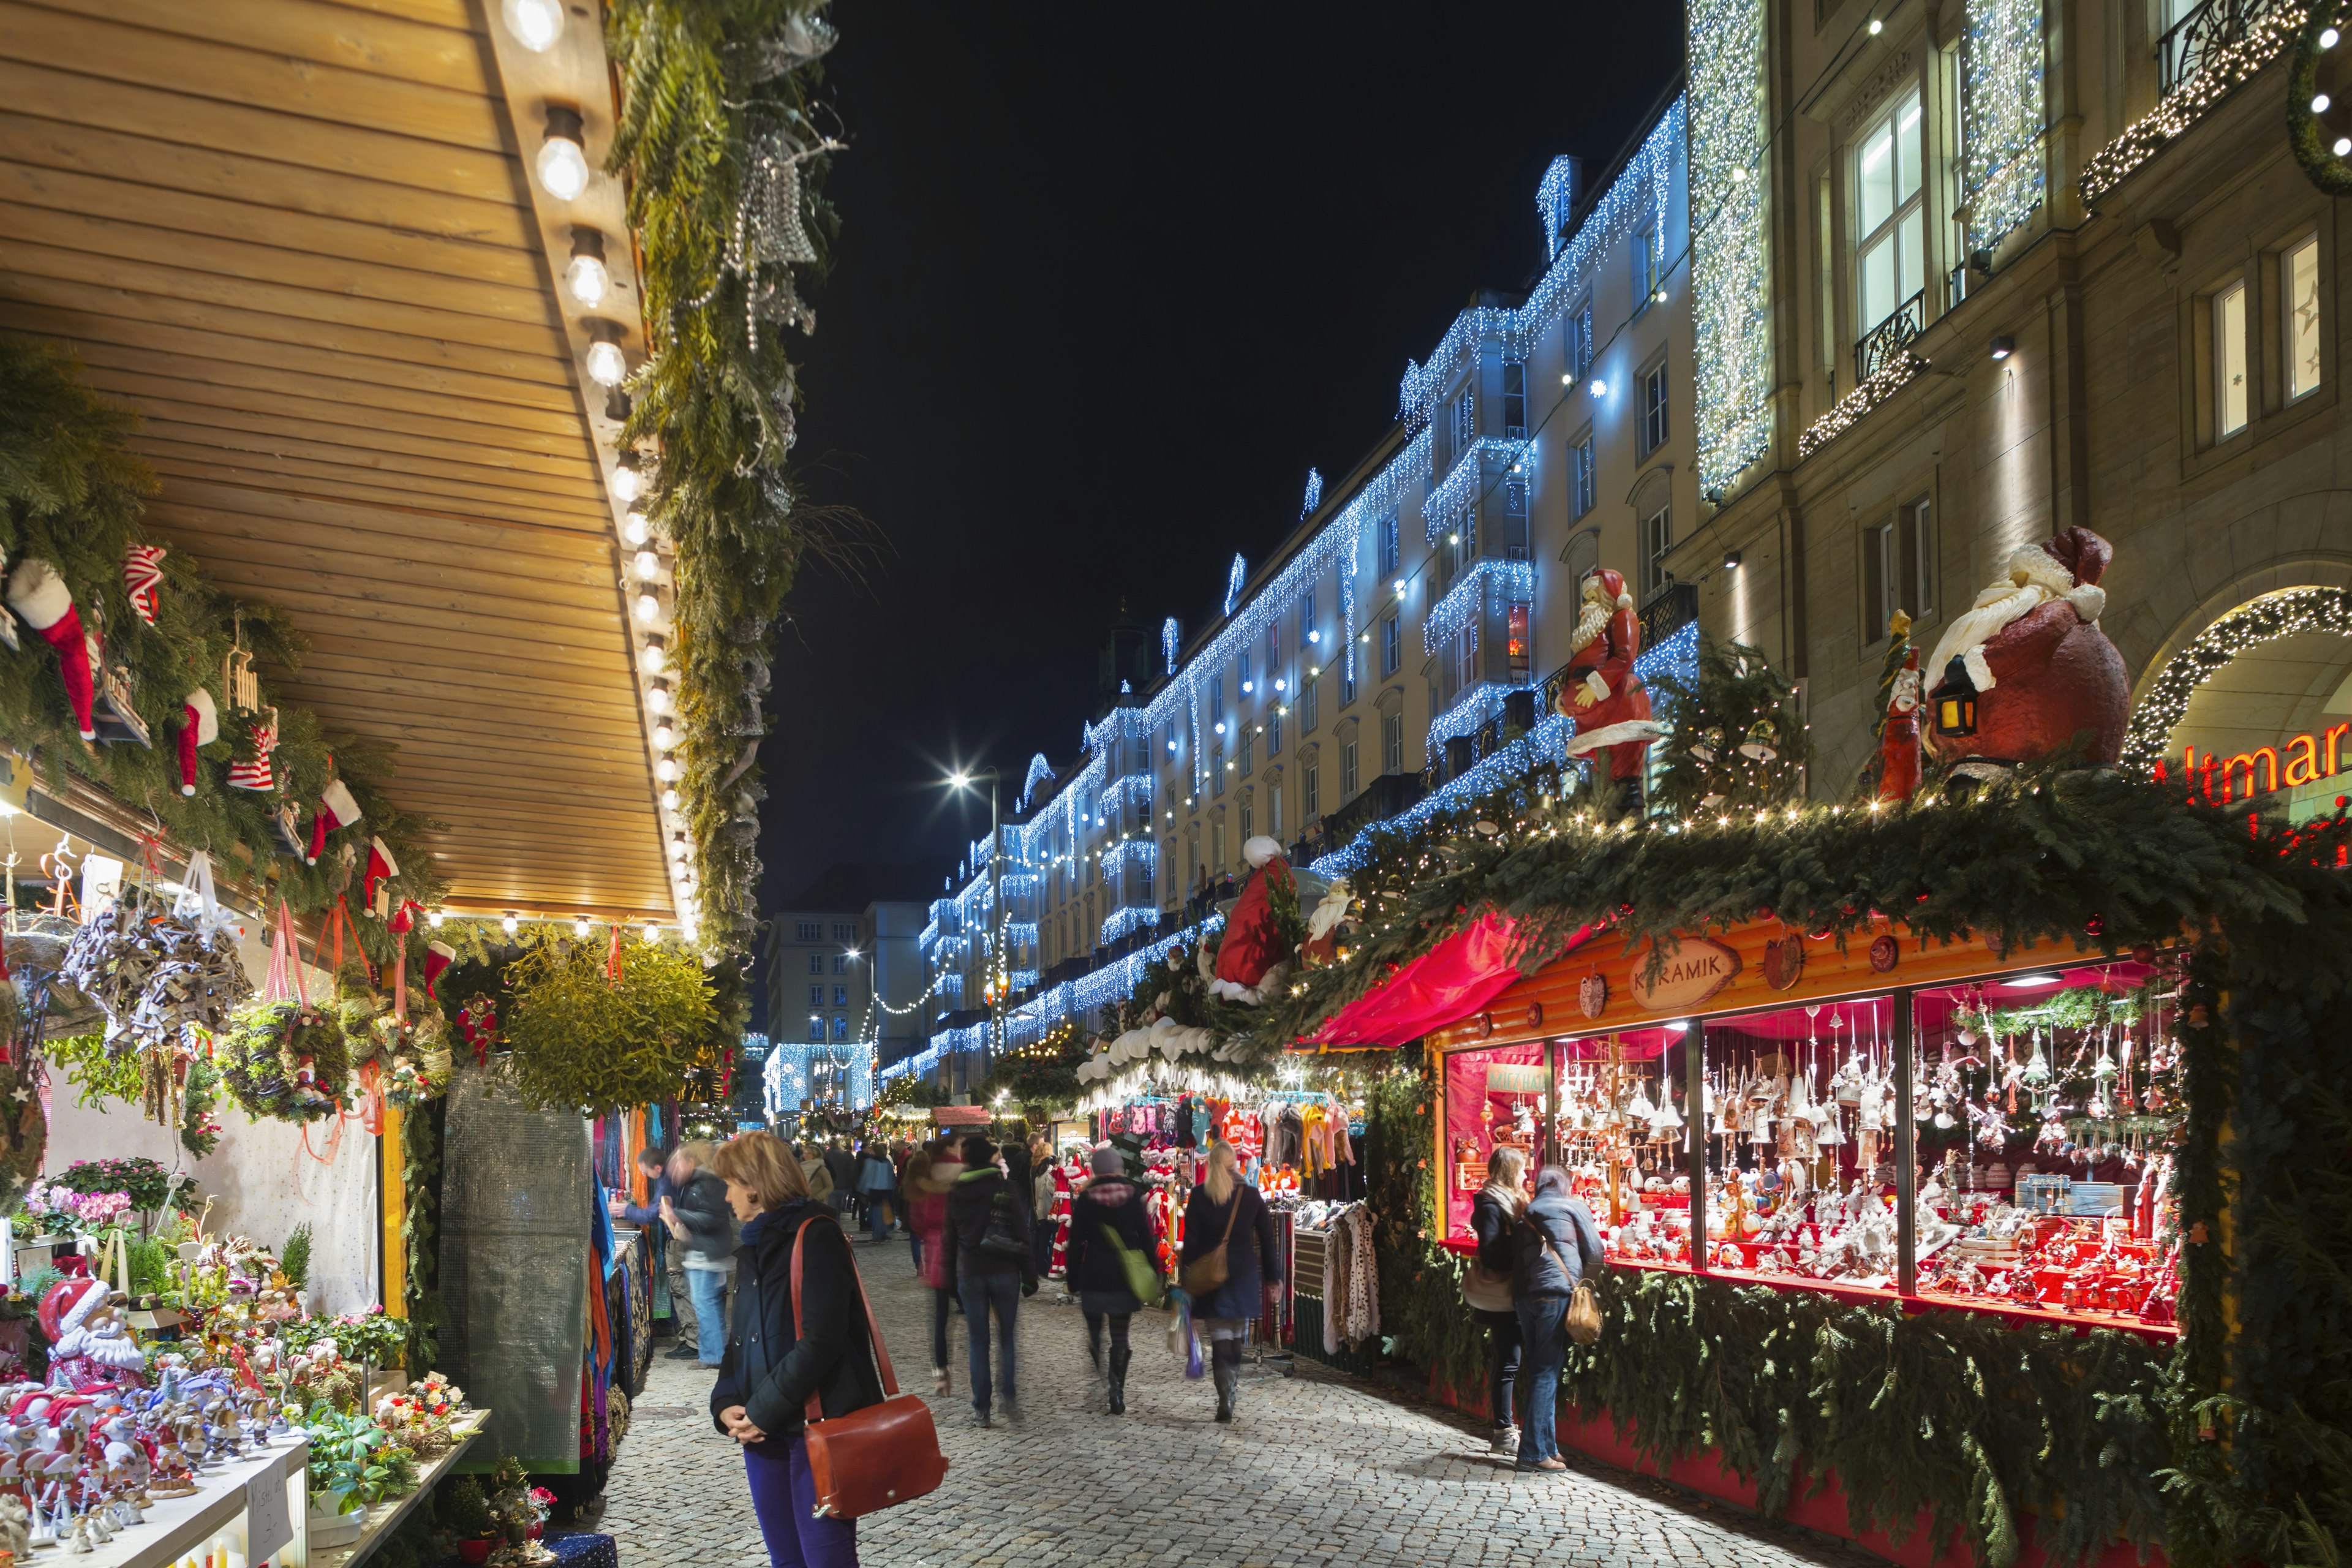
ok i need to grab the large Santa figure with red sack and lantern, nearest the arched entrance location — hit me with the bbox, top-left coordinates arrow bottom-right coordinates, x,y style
1926,529 -> 2131,778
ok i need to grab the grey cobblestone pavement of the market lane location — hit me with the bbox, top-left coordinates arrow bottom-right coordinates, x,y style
590,1242 -> 1877,1568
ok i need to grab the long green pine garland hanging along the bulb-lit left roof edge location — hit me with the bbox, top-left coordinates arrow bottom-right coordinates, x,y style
607,0 -> 832,948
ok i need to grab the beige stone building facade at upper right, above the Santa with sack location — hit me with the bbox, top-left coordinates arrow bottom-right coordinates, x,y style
1668,0 -> 2352,809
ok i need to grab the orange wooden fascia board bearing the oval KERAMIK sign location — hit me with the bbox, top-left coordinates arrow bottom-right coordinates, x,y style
1428,922 -> 2086,1051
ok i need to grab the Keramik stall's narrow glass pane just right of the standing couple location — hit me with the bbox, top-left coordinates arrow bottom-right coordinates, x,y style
1552,1020 -> 1691,1265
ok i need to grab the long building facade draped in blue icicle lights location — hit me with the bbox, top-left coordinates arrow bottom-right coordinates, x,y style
899,96 -> 1698,1088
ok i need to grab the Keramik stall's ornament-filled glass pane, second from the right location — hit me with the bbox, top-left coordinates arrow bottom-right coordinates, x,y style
1705,997 -> 1898,1295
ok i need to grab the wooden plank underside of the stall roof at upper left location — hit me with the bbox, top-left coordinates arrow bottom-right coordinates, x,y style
0,0 -> 673,919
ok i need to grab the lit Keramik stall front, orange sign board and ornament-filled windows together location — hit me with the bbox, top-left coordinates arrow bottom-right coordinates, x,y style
1428,922 -> 2183,1338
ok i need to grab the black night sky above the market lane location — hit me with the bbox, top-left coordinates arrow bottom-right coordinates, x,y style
760,0 -> 1682,910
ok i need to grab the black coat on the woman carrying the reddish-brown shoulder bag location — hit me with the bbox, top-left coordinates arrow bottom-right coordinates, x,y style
710,1201 -> 882,1458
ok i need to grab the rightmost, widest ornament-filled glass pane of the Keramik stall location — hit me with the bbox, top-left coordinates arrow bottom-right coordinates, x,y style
1912,959 -> 2180,1326
